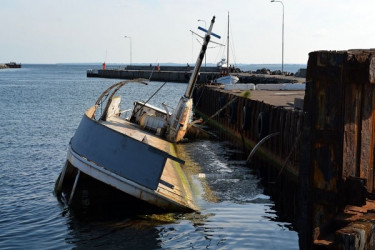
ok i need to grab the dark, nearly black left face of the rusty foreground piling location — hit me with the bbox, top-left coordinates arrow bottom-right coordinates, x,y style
304,52 -> 344,192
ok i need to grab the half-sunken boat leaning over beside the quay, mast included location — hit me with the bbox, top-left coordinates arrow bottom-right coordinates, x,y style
55,17 -> 215,212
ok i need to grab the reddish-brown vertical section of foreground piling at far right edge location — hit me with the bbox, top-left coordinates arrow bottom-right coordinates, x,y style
342,50 -> 375,193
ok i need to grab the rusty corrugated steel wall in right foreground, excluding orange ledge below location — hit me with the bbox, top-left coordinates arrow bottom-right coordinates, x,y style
301,50 -> 375,246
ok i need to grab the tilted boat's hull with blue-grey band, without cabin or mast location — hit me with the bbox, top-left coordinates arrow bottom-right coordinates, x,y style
56,109 -> 196,212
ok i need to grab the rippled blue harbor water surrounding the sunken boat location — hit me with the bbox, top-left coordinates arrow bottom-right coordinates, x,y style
0,65 -> 298,249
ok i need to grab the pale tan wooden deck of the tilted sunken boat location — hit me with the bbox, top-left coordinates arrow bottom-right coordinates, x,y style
101,117 -> 197,210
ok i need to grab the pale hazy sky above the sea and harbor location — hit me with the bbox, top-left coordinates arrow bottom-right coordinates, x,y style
0,0 -> 375,64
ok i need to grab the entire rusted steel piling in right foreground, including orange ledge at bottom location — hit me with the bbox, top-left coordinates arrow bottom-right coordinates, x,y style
301,50 -> 375,249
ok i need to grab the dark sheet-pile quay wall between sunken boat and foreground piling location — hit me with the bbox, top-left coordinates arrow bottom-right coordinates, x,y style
194,86 -> 304,182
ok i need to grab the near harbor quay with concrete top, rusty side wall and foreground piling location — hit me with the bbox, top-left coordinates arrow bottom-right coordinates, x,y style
193,50 -> 375,249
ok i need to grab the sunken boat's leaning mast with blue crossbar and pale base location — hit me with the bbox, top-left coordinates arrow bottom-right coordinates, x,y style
166,16 -> 220,142
